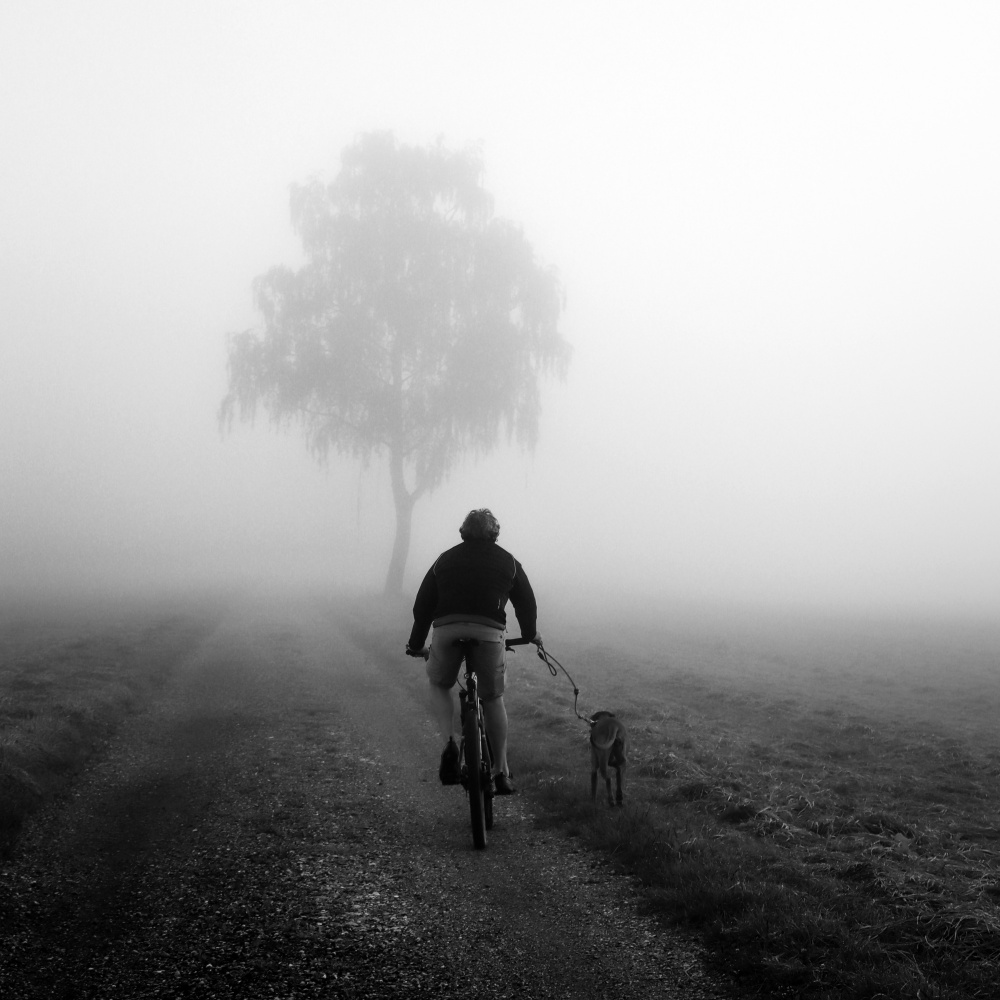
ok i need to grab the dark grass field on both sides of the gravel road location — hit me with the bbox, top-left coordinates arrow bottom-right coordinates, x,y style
0,599 -> 1000,1000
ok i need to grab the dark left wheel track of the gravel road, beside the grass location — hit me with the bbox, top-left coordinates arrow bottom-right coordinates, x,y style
0,604 -> 292,1000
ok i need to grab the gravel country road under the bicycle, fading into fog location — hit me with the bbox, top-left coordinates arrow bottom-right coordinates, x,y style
0,601 -> 732,1000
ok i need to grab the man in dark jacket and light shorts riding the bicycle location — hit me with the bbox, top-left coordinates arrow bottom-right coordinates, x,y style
406,508 -> 542,795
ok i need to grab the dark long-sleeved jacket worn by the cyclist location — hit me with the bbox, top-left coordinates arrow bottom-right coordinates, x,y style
409,539 -> 538,649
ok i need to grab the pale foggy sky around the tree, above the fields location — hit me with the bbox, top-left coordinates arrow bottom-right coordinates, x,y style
0,2 -> 1000,617
